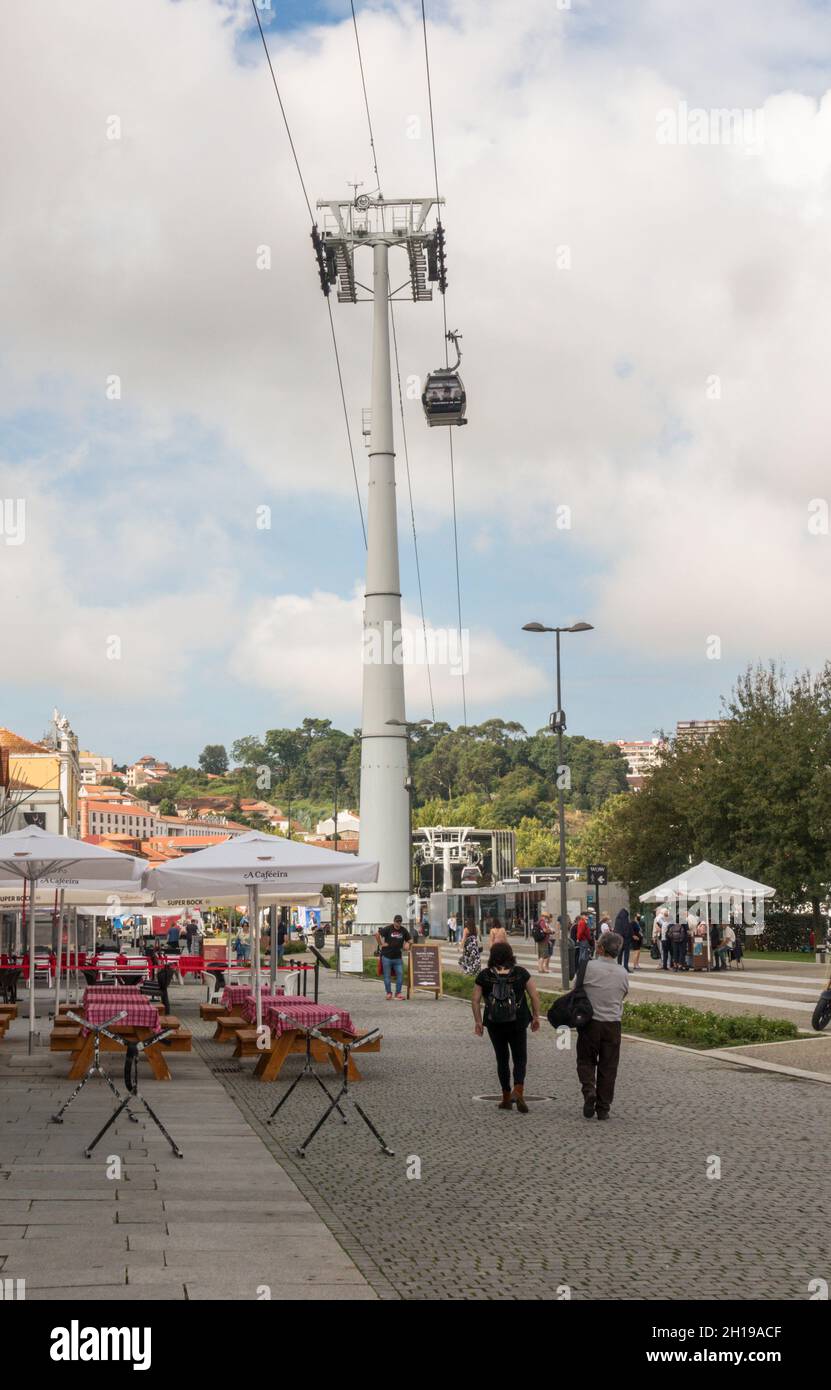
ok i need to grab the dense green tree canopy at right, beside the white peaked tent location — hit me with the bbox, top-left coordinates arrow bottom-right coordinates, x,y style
579,663 -> 831,913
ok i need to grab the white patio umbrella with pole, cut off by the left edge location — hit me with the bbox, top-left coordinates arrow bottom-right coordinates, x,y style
0,826 -> 145,1052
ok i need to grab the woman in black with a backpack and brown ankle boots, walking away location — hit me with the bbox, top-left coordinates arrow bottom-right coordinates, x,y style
471,941 -> 539,1115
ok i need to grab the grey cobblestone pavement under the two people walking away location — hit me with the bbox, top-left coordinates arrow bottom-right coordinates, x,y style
193,976 -> 831,1300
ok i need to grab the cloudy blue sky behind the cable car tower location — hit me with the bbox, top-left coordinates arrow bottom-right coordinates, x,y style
0,0 -> 831,765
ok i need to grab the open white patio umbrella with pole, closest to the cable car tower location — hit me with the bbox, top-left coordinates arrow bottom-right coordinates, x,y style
145,830 -> 378,1029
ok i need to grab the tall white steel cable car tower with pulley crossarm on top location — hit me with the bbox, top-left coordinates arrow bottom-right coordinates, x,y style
311,195 -> 445,934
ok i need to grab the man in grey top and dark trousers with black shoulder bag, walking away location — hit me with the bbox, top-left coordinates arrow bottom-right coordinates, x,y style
577,931 -> 630,1120
